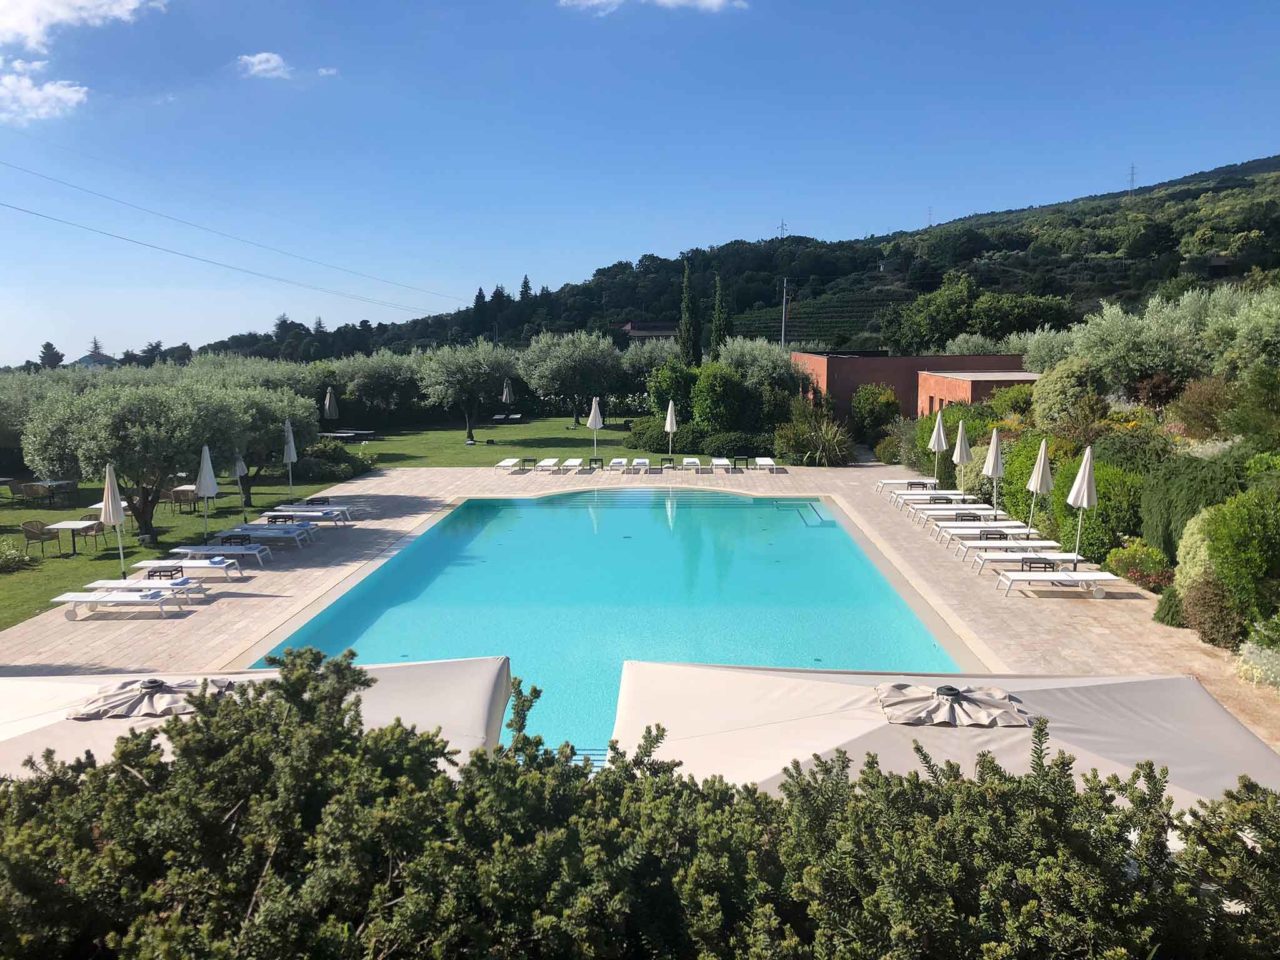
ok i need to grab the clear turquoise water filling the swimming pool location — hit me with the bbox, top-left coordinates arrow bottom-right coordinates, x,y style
264,489 -> 956,748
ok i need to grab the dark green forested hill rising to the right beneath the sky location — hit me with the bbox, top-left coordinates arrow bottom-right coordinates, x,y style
192,156 -> 1280,360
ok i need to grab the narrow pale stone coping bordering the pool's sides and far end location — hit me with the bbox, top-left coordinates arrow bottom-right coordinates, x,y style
222,484 -> 988,673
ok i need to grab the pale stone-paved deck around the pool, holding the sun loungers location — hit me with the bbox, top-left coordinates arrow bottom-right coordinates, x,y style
0,465 -> 1280,749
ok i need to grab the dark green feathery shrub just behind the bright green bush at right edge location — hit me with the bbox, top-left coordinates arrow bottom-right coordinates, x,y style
1142,452 -> 1245,559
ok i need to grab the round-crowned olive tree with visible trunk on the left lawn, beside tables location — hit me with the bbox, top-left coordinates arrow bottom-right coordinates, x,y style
22,384 -> 246,536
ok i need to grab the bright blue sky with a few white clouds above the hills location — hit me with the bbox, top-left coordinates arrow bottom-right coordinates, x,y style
0,0 -> 1280,364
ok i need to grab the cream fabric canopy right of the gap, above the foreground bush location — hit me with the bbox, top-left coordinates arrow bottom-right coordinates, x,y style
613,660 -> 1280,806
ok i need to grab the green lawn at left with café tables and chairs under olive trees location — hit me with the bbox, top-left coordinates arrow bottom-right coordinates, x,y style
0,477 -> 329,630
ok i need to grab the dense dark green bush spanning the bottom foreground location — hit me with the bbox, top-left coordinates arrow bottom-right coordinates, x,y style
0,652 -> 1280,960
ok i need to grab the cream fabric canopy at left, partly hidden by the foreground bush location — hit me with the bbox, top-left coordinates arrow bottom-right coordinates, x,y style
0,657 -> 511,777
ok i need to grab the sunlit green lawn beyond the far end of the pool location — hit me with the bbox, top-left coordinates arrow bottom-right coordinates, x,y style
362,417 -> 667,467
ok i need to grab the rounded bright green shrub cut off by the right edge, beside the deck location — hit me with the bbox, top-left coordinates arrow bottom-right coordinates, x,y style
1204,489 -> 1280,632
